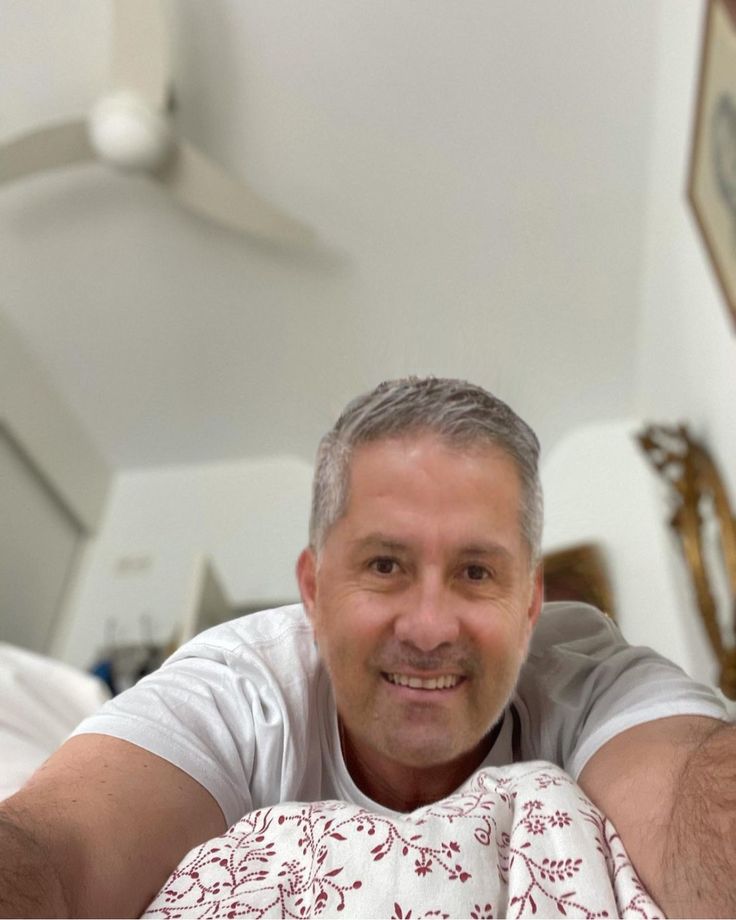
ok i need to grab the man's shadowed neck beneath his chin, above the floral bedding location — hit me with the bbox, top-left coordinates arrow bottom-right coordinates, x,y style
339,720 -> 500,812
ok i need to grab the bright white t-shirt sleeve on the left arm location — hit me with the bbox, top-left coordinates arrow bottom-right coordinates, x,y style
74,644 -> 290,825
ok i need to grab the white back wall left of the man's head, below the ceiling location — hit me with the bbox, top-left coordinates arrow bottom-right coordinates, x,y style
55,458 -> 312,667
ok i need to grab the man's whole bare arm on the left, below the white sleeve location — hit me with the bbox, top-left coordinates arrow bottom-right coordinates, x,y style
0,735 -> 226,917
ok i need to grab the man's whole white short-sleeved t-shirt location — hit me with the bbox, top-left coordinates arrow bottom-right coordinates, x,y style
75,603 -> 726,824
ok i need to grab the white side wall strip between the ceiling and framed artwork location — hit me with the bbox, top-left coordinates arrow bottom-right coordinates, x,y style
635,0 -> 736,503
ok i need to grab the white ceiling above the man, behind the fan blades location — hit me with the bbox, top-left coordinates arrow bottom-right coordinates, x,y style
0,0 -> 659,467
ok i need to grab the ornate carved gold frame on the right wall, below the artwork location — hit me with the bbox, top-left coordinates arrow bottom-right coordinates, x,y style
637,425 -> 736,700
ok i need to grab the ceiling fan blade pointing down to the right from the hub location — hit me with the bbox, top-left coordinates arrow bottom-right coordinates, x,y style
154,142 -> 314,243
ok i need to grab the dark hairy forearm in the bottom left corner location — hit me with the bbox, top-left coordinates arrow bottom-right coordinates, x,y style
0,808 -> 72,917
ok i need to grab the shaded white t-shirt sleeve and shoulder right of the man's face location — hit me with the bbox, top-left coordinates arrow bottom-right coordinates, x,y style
517,603 -> 728,779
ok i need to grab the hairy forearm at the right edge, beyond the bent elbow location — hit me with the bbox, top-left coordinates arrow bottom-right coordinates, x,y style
660,725 -> 736,917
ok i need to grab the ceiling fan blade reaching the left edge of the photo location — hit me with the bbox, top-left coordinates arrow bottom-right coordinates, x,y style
0,120 -> 95,182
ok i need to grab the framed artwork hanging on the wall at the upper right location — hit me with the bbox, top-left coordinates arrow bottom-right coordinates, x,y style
688,0 -> 736,322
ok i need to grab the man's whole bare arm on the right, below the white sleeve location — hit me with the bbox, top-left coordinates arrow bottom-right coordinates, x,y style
579,716 -> 736,917
